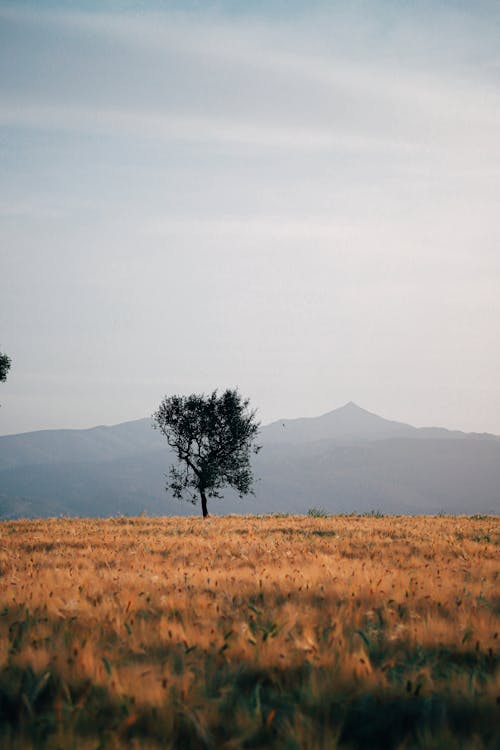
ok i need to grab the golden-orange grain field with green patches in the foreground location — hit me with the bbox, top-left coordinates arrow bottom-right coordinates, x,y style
0,516 -> 500,750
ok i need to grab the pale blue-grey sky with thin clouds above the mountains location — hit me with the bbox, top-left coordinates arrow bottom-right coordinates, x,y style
0,0 -> 500,434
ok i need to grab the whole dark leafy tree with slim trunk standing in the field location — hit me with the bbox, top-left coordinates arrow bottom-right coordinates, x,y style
153,389 -> 260,518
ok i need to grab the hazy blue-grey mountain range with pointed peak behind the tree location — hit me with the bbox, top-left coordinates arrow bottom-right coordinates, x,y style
0,402 -> 500,518
